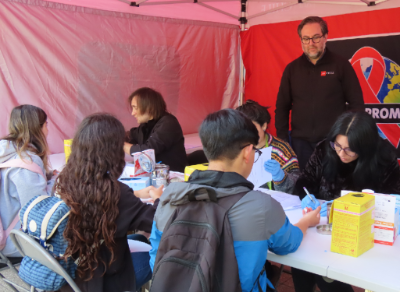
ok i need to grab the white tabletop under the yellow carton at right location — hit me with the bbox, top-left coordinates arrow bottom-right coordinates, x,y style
268,209 -> 400,292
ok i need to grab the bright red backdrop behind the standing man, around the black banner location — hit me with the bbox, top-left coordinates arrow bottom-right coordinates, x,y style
241,8 -> 400,153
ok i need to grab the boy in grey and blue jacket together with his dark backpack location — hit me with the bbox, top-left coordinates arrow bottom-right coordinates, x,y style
150,109 -> 320,292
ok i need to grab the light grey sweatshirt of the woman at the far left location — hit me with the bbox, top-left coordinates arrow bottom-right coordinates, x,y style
0,140 -> 54,257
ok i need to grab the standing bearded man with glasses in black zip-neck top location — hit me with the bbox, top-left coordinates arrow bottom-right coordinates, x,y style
275,16 -> 364,170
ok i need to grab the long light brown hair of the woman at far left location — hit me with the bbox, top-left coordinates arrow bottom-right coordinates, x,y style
2,104 -> 49,172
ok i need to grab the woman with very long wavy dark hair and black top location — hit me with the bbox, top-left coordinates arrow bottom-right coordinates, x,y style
56,114 -> 162,292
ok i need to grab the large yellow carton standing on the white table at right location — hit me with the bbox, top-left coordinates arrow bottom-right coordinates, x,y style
330,193 -> 375,257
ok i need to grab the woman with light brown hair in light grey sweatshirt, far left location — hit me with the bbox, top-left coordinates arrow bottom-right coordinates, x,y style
0,104 -> 52,257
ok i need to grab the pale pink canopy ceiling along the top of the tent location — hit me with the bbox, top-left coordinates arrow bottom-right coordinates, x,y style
41,0 -> 400,28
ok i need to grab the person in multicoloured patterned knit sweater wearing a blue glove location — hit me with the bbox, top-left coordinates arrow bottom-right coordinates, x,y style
236,100 -> 300,193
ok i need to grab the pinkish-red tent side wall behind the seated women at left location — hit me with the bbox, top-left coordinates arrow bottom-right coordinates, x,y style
0,0 -> 239,153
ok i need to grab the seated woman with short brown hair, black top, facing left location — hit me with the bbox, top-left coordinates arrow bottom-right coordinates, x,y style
124,87 -> 187,172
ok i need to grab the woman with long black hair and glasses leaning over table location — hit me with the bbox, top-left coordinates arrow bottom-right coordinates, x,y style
292,112 -> 400,292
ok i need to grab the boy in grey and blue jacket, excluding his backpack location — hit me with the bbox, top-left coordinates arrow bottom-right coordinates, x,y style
150,109 -> 320,292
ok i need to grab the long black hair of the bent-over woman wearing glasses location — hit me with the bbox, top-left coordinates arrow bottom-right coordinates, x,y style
323,112 -> 396,189
